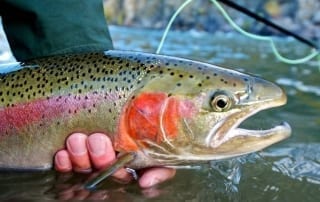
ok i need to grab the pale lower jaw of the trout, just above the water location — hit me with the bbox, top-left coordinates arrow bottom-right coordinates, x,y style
186,115 -> 291,160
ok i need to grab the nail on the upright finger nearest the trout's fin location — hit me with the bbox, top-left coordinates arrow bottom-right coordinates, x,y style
88,135 -> 106,156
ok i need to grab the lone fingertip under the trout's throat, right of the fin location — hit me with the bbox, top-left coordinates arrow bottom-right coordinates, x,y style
139,168 -> 176,188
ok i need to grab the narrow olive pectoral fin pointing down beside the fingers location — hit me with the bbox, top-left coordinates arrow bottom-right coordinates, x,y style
84,153 -> 136,189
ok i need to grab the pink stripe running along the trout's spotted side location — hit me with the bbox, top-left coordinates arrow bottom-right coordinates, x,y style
0,92 -> 117,136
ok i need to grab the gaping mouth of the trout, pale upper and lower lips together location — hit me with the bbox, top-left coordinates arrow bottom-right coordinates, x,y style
206,79 -> 291,158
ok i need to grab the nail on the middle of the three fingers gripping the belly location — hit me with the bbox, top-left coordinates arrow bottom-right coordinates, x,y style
67,135 -> 87,156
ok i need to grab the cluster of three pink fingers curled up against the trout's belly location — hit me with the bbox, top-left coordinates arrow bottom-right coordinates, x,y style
54,133 -> 132,182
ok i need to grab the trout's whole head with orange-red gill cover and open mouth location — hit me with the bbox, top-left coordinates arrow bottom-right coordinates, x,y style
114,52 -> 291,165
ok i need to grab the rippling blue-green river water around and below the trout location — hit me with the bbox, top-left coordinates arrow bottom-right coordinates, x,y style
0,27 -> 320,202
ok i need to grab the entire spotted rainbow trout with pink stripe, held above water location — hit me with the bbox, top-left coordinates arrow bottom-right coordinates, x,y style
0,51 -> 291,181
